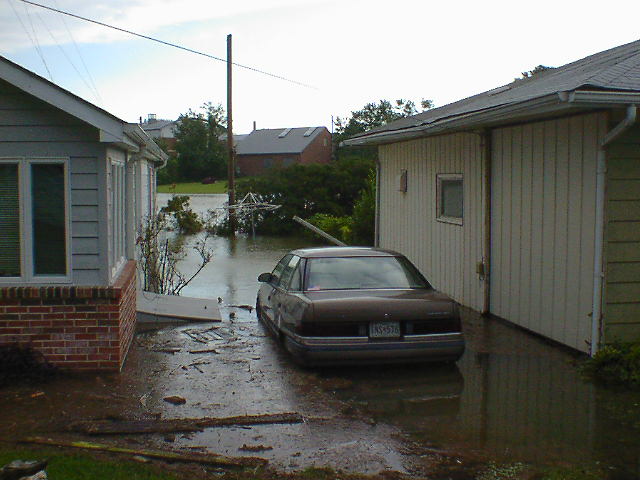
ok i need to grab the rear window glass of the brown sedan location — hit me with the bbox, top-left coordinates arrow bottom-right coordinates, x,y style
305,257 -> 430,290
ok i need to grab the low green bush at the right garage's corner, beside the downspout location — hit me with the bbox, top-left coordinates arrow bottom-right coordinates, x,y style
582,341 -> 640,389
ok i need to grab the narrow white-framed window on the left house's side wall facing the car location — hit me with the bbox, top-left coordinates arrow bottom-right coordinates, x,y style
109,157 -> 127,279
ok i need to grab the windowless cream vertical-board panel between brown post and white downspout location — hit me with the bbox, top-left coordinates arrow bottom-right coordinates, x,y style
491,114 -> 606,351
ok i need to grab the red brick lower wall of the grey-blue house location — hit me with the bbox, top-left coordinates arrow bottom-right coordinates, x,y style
0,261 -> 136,371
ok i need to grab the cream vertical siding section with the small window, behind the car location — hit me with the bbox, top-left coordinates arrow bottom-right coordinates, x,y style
379,133 -> 484,310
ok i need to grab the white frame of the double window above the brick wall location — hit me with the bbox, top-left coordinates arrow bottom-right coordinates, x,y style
0,157 -> 73,284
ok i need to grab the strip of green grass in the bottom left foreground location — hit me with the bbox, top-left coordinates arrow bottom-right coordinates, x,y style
0,448 -> 178,480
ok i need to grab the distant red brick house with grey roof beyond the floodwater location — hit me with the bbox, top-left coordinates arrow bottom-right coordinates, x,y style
236,127 -> 331,175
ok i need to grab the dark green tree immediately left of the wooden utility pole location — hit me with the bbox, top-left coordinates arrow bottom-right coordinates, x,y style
174,102 -> 227,181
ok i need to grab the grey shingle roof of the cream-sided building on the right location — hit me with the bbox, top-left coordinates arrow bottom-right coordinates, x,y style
353,40 -> 640,138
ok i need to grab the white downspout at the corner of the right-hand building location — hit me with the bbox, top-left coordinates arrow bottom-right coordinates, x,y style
590,105 -> 637,357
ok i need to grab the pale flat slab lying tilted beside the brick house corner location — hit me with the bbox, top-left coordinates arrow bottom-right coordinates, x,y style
136,290 -> 222,323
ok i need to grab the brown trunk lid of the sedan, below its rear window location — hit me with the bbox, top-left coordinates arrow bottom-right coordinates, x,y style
305,289 -> 457,321
